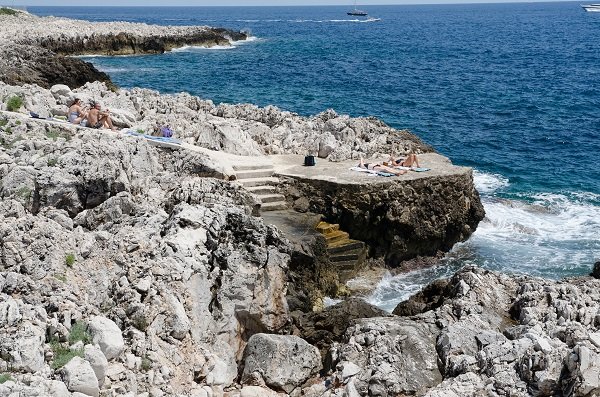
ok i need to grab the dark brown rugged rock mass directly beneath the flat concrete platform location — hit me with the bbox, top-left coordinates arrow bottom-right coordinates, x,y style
282,168 -> 485,266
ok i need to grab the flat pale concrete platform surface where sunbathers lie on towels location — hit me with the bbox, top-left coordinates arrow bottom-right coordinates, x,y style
269,153 -> 470,184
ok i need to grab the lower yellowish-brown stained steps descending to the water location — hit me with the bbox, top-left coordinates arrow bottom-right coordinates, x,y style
316,221 -> 367,282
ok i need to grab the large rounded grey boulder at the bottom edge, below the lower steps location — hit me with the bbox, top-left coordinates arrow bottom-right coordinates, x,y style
242,334 -> 321,393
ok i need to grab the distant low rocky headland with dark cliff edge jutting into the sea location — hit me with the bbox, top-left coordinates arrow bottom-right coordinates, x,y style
0,12 -> 247,89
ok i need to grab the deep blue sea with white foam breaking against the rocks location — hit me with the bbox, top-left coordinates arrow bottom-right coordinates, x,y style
28,2 -> 600,310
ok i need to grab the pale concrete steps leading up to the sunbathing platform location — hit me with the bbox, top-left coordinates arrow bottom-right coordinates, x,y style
233,164 -> 287,211
